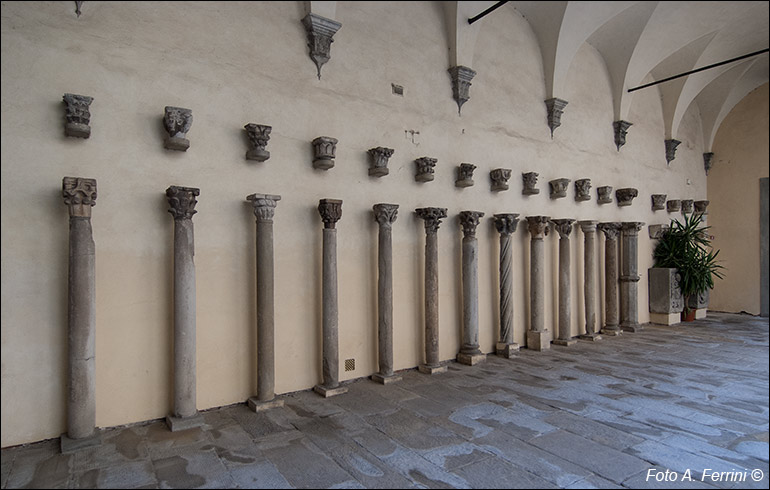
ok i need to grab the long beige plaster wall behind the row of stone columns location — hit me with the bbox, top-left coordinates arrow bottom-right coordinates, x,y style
2,2 -> 708,446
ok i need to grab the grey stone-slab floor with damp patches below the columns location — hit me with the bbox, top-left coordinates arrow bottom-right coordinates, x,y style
2,313 -> 770,489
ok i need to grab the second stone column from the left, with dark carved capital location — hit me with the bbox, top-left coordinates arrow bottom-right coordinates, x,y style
166,185 -> 203,432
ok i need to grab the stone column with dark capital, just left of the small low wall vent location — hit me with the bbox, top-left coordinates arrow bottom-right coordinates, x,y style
313,199 -> 348,398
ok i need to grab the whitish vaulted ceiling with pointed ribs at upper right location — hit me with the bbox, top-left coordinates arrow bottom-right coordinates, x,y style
308,1 -> 770,152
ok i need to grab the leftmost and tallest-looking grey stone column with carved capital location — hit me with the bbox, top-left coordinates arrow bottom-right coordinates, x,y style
59,177 -> 101,453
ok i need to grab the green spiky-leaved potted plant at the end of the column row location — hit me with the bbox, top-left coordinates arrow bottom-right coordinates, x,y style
653,213 -> 724,313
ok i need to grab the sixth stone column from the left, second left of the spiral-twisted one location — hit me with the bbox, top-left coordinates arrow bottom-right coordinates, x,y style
415,208 -> 447,374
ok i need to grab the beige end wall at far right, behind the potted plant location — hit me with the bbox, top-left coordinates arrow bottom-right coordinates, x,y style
708,84 -> 770,315
